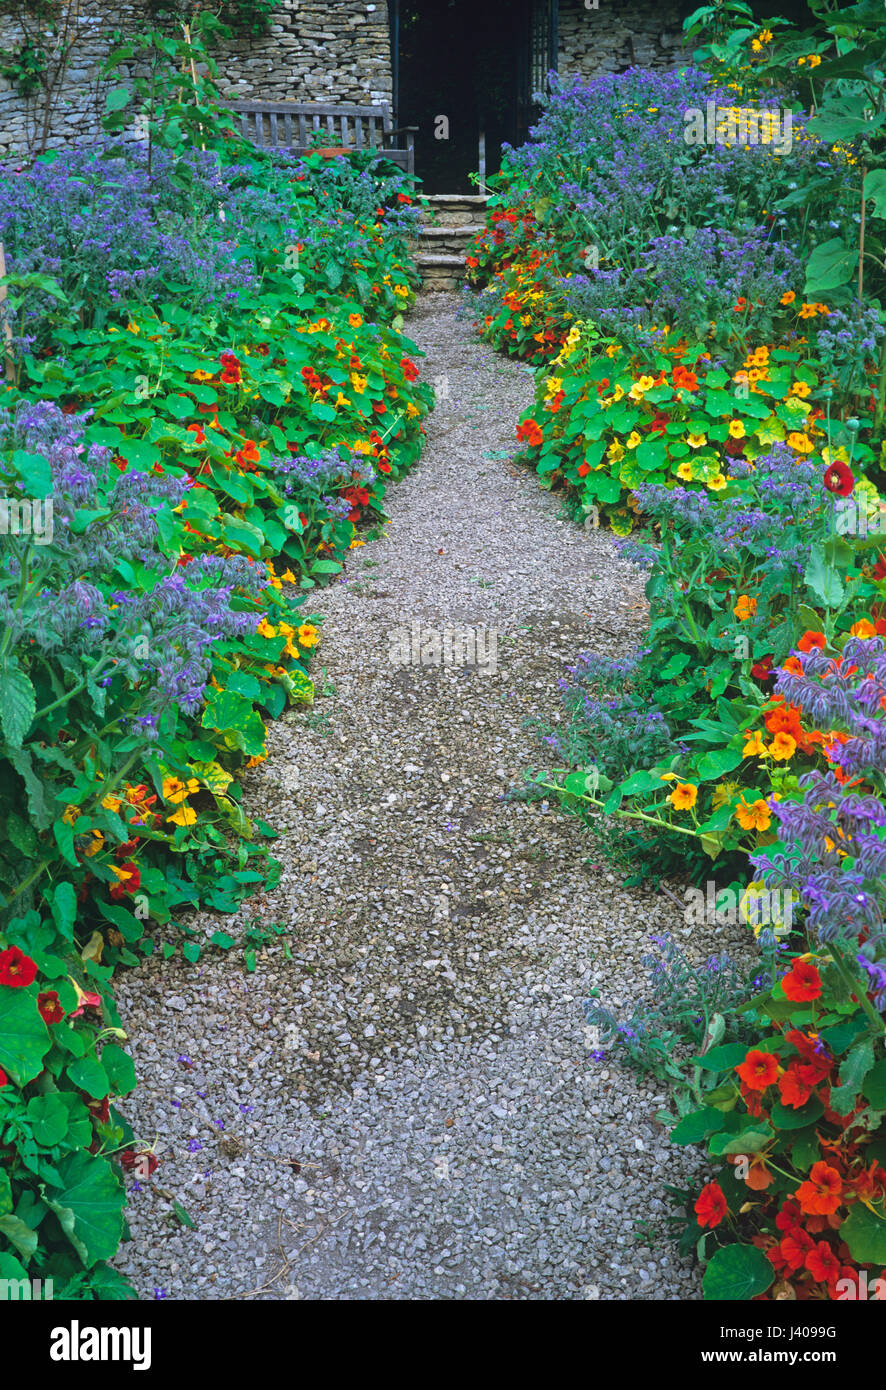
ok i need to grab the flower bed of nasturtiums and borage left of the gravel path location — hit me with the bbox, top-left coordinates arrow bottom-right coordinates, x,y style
0,19 -> 431,1300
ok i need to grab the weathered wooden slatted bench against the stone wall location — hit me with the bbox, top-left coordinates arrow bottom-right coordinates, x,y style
229,101 -> 419,174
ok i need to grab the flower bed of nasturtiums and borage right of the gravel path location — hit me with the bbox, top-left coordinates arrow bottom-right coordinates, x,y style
467,4 -> 886,1300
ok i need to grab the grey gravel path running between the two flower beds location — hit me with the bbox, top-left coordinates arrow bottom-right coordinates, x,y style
117,296 -> 723,1300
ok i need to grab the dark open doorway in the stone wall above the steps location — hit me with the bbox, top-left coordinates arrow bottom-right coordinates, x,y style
396,0 -> 556,193
